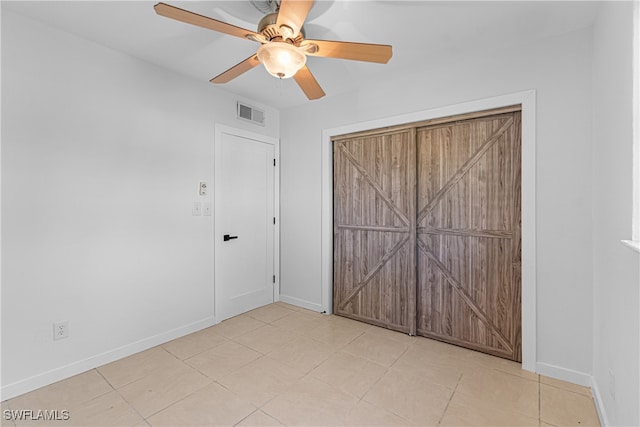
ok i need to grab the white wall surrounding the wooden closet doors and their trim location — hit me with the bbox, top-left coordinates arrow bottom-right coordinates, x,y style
281,29 -> 593,382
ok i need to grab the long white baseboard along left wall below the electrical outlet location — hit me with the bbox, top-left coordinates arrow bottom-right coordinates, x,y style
0,317 -> 217,401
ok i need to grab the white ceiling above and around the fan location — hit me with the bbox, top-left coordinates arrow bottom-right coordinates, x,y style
1,0 -> 598,109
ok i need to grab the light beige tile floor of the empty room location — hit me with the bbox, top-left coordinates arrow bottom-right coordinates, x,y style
2,303 -> 599,426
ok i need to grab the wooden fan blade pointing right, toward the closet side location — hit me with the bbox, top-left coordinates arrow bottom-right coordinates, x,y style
301,40 -> 393,64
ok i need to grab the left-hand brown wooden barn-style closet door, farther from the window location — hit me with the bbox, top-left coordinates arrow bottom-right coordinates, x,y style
333,129 -> 416,334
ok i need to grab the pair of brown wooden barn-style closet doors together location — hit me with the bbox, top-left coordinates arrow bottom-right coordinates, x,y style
332,105 -> 522,361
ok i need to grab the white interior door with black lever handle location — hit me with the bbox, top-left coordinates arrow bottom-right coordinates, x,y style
214,127 -> 275,320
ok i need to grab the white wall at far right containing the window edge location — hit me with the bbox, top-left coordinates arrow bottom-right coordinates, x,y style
592,2 -> 640,426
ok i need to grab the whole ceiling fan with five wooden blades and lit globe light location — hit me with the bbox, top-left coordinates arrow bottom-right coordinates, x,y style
154,0 -> 392,99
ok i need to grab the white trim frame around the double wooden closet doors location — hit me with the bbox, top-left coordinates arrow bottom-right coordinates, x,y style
321,90 -> 537,372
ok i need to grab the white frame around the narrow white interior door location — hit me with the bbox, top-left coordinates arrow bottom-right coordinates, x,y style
211,123 -> 280,323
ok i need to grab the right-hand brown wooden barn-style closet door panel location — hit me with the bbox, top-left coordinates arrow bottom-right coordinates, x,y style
417,112 -> 521,361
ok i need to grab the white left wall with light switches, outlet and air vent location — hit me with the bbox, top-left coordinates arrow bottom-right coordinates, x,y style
1,9 -> 279,399
